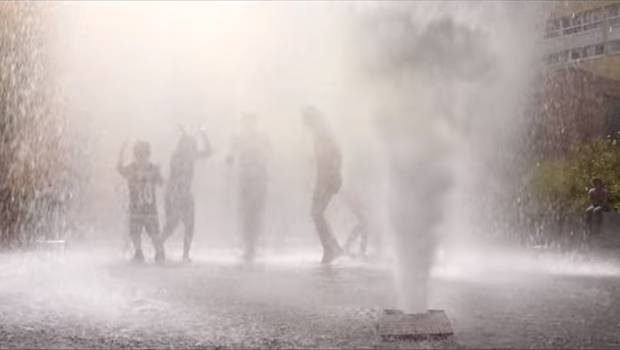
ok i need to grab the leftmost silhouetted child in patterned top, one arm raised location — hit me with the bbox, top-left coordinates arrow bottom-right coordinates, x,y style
117,141 -> 164,262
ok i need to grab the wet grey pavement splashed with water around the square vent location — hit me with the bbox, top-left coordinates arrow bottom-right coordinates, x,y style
0,247 -> 620,348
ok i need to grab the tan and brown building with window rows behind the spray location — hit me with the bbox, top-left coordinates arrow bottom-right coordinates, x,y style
537,0 -> 620,157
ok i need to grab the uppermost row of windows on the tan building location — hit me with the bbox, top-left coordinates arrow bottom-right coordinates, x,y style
545,3 -> 620,38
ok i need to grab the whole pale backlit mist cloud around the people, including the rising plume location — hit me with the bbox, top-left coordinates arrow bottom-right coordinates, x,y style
44,2 -> 540,311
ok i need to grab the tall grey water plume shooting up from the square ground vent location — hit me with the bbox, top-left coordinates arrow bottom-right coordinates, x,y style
352,3 -> 539,312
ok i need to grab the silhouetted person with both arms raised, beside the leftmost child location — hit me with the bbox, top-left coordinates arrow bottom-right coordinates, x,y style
162,128 -> 212,262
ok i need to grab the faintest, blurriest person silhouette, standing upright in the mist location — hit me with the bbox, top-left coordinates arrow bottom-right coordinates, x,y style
227,114 -> 271,262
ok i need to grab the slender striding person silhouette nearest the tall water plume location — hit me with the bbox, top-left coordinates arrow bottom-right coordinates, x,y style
302,107 -> 344,264
